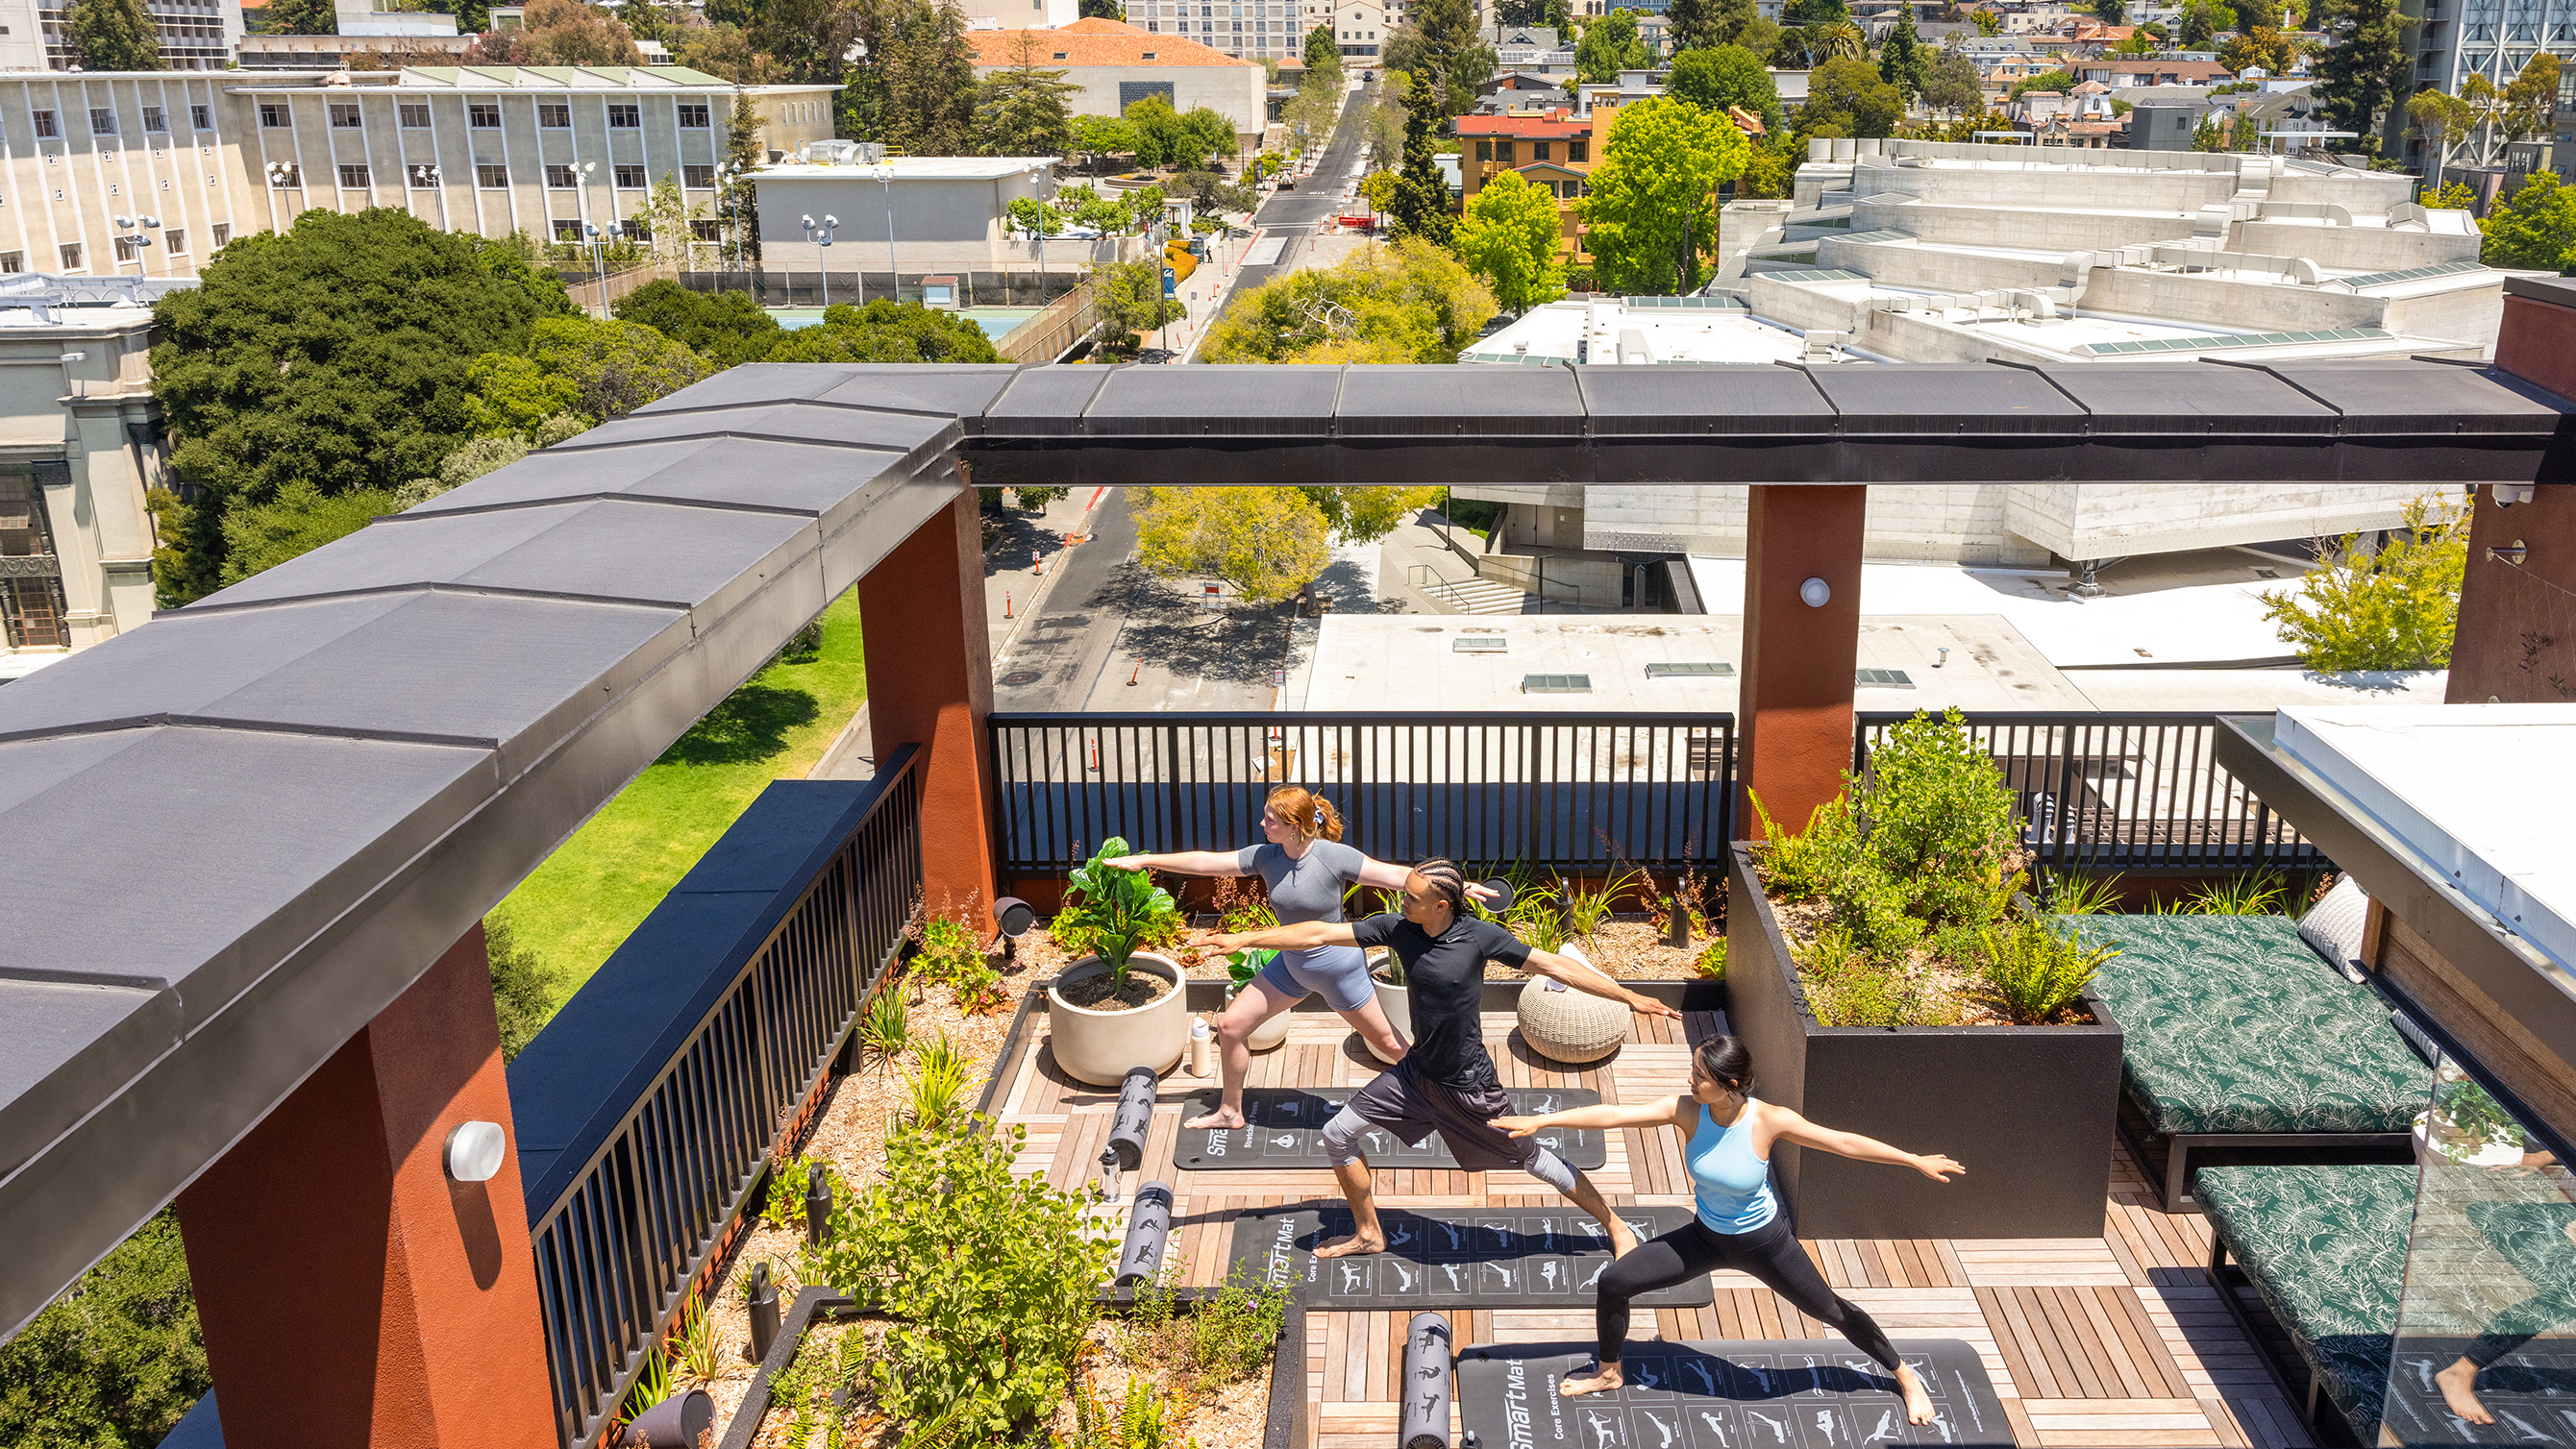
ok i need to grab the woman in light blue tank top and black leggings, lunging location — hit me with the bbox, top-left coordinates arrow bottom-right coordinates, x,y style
1494,1037 -> 1969,1423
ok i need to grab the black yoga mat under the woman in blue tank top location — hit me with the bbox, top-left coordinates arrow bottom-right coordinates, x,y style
1455,1338 -> 2012,1449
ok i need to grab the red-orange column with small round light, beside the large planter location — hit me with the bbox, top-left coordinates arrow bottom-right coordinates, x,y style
1736,484 -> 1870,839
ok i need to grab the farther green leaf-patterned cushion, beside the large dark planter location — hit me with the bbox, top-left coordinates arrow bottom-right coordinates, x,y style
2071,917 -> 2432,1133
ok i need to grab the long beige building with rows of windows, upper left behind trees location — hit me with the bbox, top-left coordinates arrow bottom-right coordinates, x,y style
0,67 -> 832,278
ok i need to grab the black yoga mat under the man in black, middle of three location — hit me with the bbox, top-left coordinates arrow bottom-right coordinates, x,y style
1228,1205 -> 1716,1310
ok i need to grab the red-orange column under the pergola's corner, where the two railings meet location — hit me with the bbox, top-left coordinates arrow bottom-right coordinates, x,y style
857,489 -> 994,929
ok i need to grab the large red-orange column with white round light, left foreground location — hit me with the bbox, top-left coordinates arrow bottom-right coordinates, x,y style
178,926 -> 557,1449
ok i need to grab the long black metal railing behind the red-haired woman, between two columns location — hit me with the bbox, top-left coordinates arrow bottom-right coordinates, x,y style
992,713 -> 1736,875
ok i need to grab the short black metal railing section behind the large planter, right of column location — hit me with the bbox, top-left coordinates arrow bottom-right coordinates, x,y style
1852,713 -> 2326,872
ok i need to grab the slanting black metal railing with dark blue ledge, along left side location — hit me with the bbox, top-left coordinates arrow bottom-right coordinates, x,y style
510,747 -> 922,1449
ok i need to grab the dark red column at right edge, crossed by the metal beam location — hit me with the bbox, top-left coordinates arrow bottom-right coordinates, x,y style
2442,283 -> 2576,705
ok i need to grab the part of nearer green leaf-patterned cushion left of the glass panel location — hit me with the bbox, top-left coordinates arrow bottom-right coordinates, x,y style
2192,1163 -> 2416,1444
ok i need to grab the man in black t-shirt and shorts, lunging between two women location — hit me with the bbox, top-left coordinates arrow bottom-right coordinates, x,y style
1216,860 -> 1679,1259
